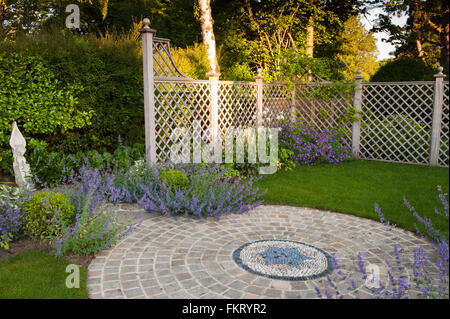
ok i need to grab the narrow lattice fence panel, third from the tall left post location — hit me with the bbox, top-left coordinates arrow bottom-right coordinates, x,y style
262,83 -> 292,125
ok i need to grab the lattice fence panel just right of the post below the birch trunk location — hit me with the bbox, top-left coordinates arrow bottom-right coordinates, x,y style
218,82 -> 257,134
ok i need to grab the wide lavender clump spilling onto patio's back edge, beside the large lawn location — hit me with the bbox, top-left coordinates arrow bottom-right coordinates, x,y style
138,165 -> 265,219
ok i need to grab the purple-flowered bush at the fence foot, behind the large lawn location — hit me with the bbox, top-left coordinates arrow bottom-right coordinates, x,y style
279,119 -> 352,167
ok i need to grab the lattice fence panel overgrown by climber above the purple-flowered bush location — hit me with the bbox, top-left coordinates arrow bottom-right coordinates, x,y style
295,84 -> 353,146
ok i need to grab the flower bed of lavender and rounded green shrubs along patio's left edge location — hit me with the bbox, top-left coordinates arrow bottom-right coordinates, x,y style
0,161 -> 263,256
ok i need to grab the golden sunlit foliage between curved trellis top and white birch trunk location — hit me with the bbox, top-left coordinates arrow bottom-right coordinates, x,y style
171,43 -> 210,80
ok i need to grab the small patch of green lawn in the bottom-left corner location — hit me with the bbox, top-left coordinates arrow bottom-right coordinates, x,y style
0,251 -> 87,299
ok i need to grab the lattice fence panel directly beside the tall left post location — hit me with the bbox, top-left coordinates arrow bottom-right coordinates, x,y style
155,81 -> 210,161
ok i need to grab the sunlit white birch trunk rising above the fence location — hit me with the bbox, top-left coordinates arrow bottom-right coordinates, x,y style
198,0 -> 220,73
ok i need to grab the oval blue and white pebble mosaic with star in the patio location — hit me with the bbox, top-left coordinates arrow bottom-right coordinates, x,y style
233,240 -> 333,280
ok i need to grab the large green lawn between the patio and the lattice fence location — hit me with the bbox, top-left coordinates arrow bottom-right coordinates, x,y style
257,161 -> 449,237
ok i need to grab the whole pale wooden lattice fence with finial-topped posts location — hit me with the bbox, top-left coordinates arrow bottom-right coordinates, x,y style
140,19 -> 449,167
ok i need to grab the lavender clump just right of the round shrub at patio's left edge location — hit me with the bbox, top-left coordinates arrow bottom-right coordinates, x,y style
48,166 -> 139,256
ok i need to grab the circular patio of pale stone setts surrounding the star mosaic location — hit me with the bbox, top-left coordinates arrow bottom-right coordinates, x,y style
87,205 -> 431,299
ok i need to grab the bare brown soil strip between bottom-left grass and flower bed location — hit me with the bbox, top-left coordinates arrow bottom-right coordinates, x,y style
0,237 -> 95,268
